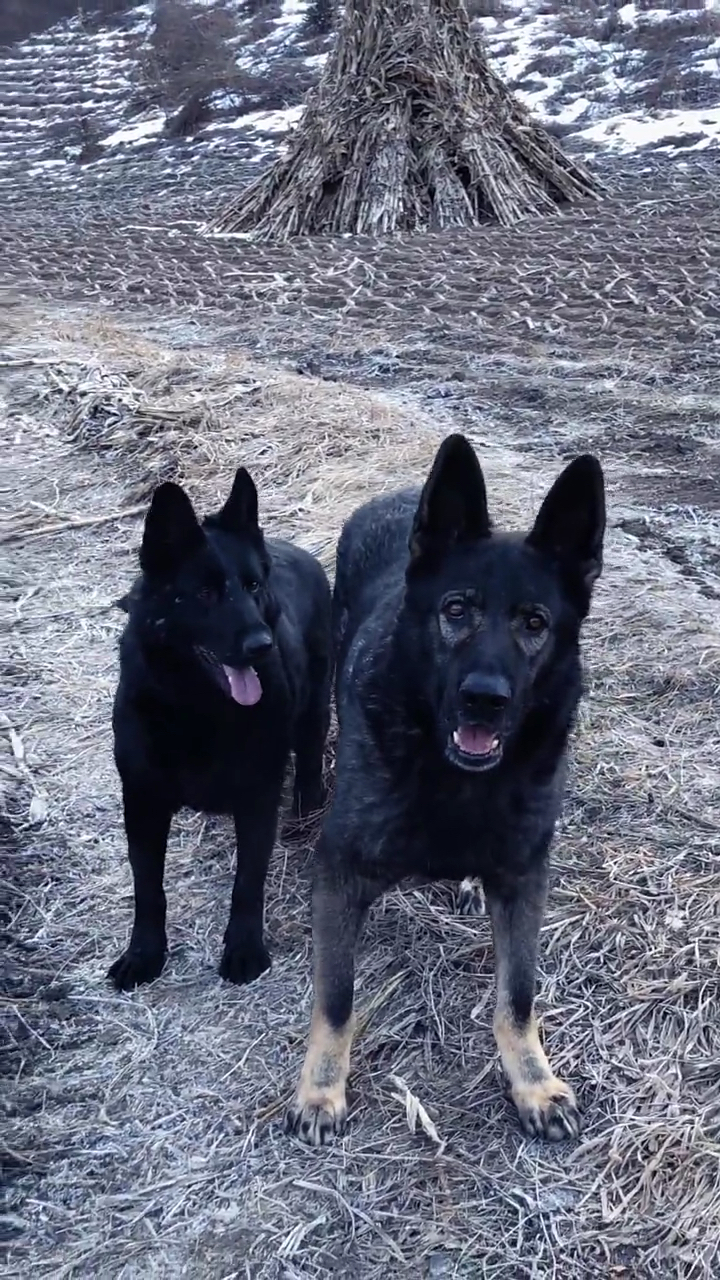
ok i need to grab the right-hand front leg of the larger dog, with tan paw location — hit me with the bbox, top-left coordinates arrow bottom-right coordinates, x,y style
486,865 -> 580,1142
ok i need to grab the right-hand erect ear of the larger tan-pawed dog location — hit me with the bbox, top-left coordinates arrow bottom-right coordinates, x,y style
527,453 -> 605,591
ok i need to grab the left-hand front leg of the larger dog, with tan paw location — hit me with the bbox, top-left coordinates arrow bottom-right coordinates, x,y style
286,868 -> 380,1147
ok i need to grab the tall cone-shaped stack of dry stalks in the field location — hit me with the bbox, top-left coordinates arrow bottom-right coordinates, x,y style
210,0 -> 600,239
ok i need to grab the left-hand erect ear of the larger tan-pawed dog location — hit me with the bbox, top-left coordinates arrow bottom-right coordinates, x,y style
410,435 -> 491,561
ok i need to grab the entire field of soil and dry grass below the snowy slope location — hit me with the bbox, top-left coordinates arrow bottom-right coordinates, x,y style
0,10 -> 720,1280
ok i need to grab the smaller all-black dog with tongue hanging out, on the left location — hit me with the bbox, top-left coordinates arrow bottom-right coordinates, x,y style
109,467 -> 332,989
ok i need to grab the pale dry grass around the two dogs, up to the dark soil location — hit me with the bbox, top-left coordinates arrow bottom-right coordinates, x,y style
5,317 -> 720,1280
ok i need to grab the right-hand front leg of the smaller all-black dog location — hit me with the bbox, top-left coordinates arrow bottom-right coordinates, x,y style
219,785 -> 282,984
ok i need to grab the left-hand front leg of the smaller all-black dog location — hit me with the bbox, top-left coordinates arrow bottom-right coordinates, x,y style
108,778 -> 172,991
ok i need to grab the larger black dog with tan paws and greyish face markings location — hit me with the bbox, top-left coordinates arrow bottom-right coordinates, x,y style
288,435 -> 605,1144
